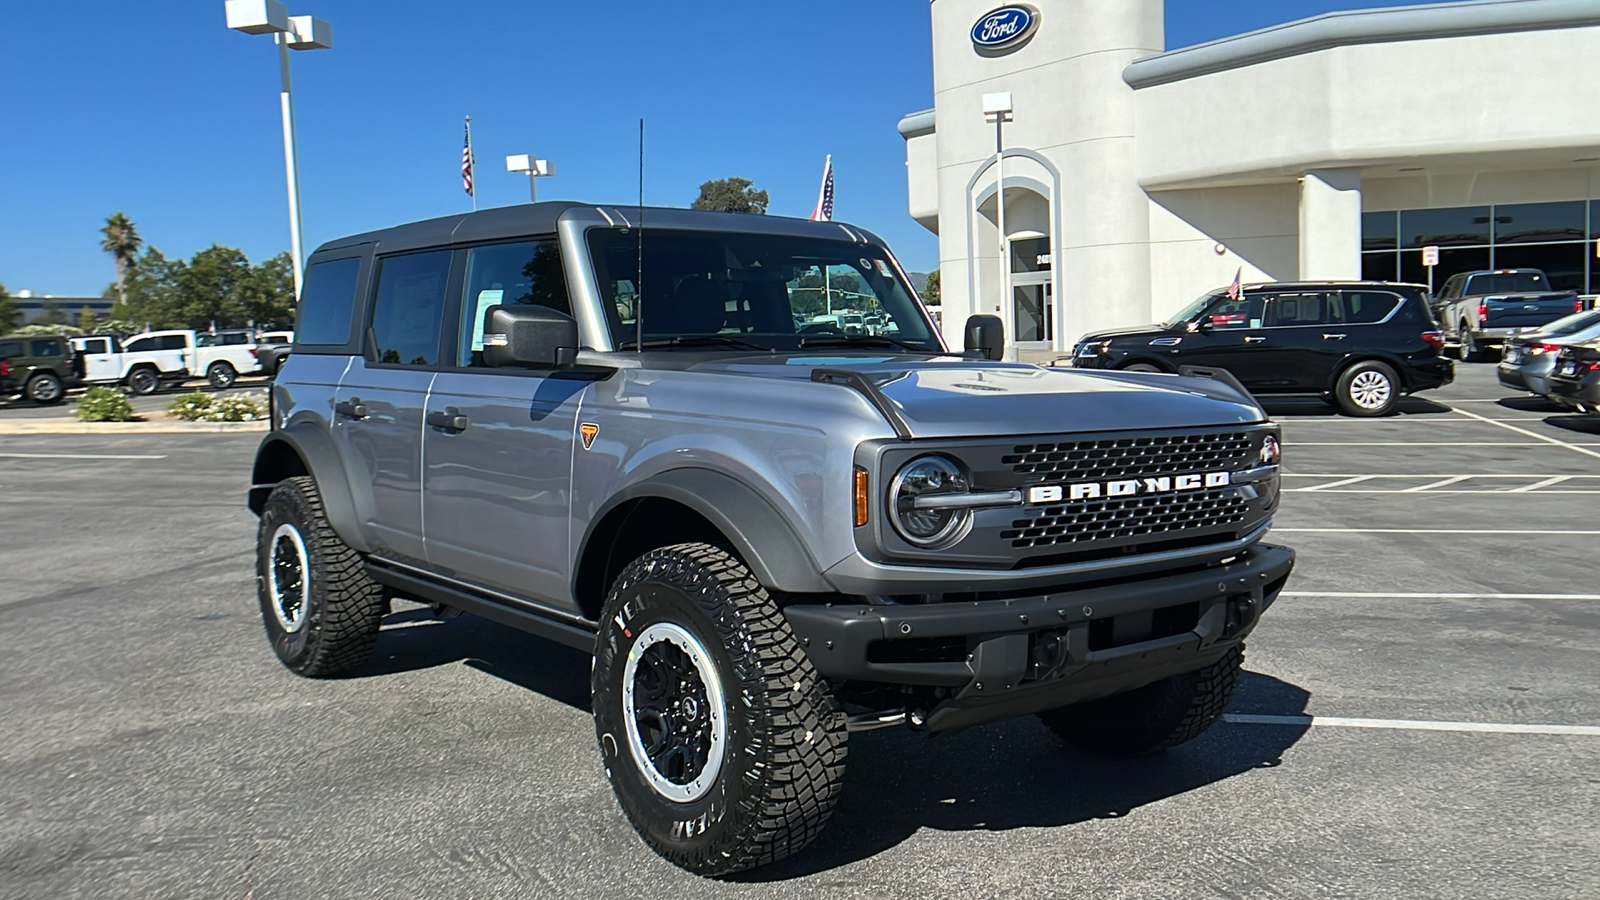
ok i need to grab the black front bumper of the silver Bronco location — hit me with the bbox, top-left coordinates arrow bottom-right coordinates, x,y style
784,544 -> 1294,732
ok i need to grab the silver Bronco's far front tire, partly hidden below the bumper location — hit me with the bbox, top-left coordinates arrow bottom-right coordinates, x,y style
1038,645 -> 1245,756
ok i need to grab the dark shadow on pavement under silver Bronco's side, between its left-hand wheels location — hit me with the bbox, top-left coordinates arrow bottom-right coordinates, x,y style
355,609 -> 590,713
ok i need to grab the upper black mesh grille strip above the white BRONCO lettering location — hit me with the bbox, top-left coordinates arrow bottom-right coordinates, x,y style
1000,431 -> 1254,480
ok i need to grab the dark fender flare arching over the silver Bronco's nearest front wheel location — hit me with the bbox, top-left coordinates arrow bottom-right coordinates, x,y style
585,468 -> 834,594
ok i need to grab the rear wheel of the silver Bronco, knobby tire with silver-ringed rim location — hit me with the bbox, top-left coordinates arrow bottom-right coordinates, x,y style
256,476 -> 387,677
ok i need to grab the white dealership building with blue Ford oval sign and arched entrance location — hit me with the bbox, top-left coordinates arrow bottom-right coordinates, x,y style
899,0 -> 1600,357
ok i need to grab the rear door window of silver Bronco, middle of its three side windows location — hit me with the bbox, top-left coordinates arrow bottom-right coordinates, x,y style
373,250 -> 450,365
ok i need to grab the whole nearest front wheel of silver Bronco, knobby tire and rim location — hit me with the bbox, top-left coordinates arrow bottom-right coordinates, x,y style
590,543 -> 846,874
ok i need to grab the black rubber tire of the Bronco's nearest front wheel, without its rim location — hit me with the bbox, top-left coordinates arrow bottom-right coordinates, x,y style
590,543 -> 846,876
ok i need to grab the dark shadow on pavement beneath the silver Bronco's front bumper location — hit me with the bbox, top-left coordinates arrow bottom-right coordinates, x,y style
731,673 -> 1310,882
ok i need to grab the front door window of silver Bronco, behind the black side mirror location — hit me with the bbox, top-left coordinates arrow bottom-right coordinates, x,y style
456,239 -> 573,365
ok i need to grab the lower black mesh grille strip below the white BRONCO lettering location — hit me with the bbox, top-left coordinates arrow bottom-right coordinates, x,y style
1000,483 -> 1248,549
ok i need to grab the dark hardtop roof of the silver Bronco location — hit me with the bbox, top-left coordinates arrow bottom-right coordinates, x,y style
317,200 -> 883,253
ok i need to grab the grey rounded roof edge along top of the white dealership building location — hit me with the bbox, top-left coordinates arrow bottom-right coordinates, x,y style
1126,0 -> 1600,88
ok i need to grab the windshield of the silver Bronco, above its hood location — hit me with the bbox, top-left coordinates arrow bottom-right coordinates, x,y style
589,227 -> 942,352
